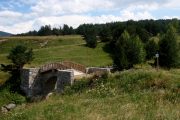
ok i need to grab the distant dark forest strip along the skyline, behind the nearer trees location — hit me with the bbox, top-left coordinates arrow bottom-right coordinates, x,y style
18,19 -> 180,37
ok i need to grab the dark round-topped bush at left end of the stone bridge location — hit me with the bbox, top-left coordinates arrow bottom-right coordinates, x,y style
1,45 -> 33,92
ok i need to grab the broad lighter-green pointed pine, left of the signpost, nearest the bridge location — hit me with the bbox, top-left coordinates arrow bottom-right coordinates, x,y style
113,30 -> 145,70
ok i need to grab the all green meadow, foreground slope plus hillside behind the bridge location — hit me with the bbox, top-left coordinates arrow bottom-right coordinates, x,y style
0,35 -> 180,120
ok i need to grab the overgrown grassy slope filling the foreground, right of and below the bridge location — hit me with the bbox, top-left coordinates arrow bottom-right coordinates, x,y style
1,69 -> 180,120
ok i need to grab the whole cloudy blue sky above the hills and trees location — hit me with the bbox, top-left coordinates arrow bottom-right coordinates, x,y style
0,0 -> 180,34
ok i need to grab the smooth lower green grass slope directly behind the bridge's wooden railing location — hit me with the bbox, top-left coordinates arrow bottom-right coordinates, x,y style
32,44 -> 112,66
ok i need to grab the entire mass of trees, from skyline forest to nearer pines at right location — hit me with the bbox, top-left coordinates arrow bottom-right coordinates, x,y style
16,19 -> 180,70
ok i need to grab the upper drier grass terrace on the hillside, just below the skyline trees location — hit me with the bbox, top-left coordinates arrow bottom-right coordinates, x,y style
0,35 -> 84,54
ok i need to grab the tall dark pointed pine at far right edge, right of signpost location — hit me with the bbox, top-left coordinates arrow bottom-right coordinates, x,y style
159,26 -> 179,68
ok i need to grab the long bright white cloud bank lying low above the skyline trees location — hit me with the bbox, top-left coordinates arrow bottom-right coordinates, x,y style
11,12 -> 153,33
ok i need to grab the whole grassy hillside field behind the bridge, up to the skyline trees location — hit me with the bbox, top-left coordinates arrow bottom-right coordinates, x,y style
0,35 -> 112,84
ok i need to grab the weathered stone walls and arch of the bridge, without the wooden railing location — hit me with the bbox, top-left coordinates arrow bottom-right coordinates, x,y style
21,68 -> 74,97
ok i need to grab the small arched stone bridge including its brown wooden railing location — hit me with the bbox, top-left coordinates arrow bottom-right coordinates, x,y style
21,61 -> 86,97
